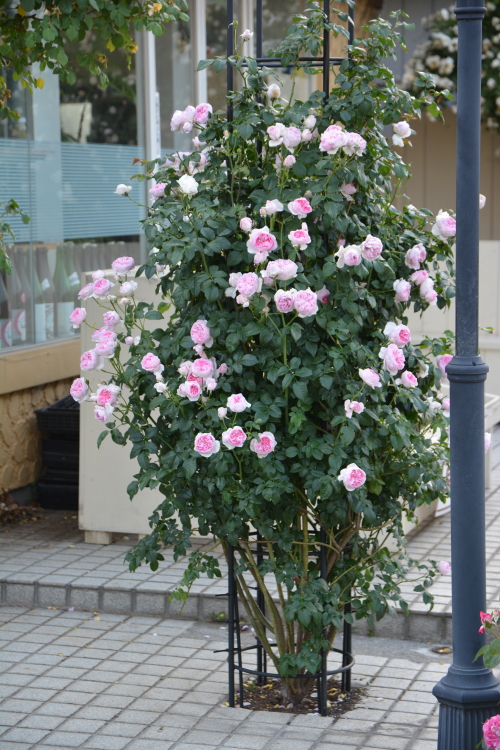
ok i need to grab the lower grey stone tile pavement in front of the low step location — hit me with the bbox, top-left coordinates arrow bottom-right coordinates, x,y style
0,605 -> 468,750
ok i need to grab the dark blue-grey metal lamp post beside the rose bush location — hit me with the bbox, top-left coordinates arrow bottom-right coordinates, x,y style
433,0 -> 500,750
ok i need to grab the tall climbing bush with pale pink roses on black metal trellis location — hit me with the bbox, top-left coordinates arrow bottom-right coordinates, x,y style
72,6 -> 453,703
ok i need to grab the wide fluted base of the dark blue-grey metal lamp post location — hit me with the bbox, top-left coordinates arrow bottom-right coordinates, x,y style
432,666 -> 500,750
